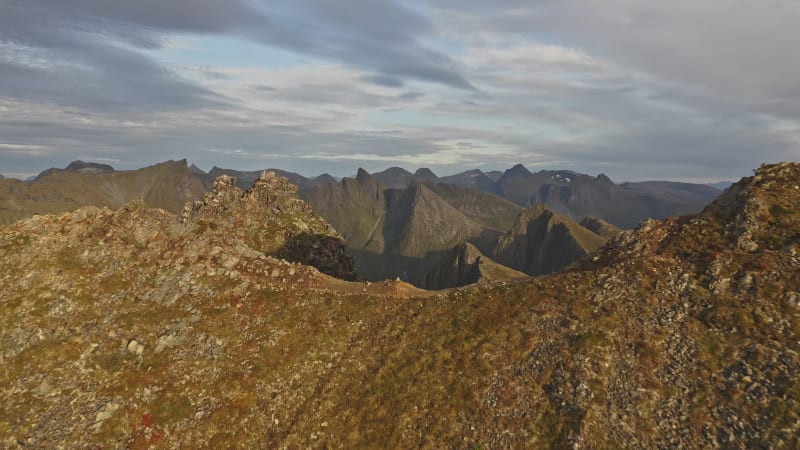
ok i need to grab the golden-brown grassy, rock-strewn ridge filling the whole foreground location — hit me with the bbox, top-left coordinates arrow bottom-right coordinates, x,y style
0,163 -> 800,449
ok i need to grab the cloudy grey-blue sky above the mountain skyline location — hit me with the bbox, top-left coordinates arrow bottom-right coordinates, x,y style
0,0 -> 800,182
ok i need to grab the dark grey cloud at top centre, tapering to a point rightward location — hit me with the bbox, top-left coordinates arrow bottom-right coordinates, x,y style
243,0 -> 475,90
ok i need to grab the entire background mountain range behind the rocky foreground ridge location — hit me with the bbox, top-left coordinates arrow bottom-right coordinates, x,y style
0,160 -> 719,289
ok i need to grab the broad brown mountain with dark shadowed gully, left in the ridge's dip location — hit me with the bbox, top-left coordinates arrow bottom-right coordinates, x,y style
302,176 -> 520,289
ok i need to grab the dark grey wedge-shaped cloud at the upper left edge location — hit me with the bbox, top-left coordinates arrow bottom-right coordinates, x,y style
0,1 -> 223,113
